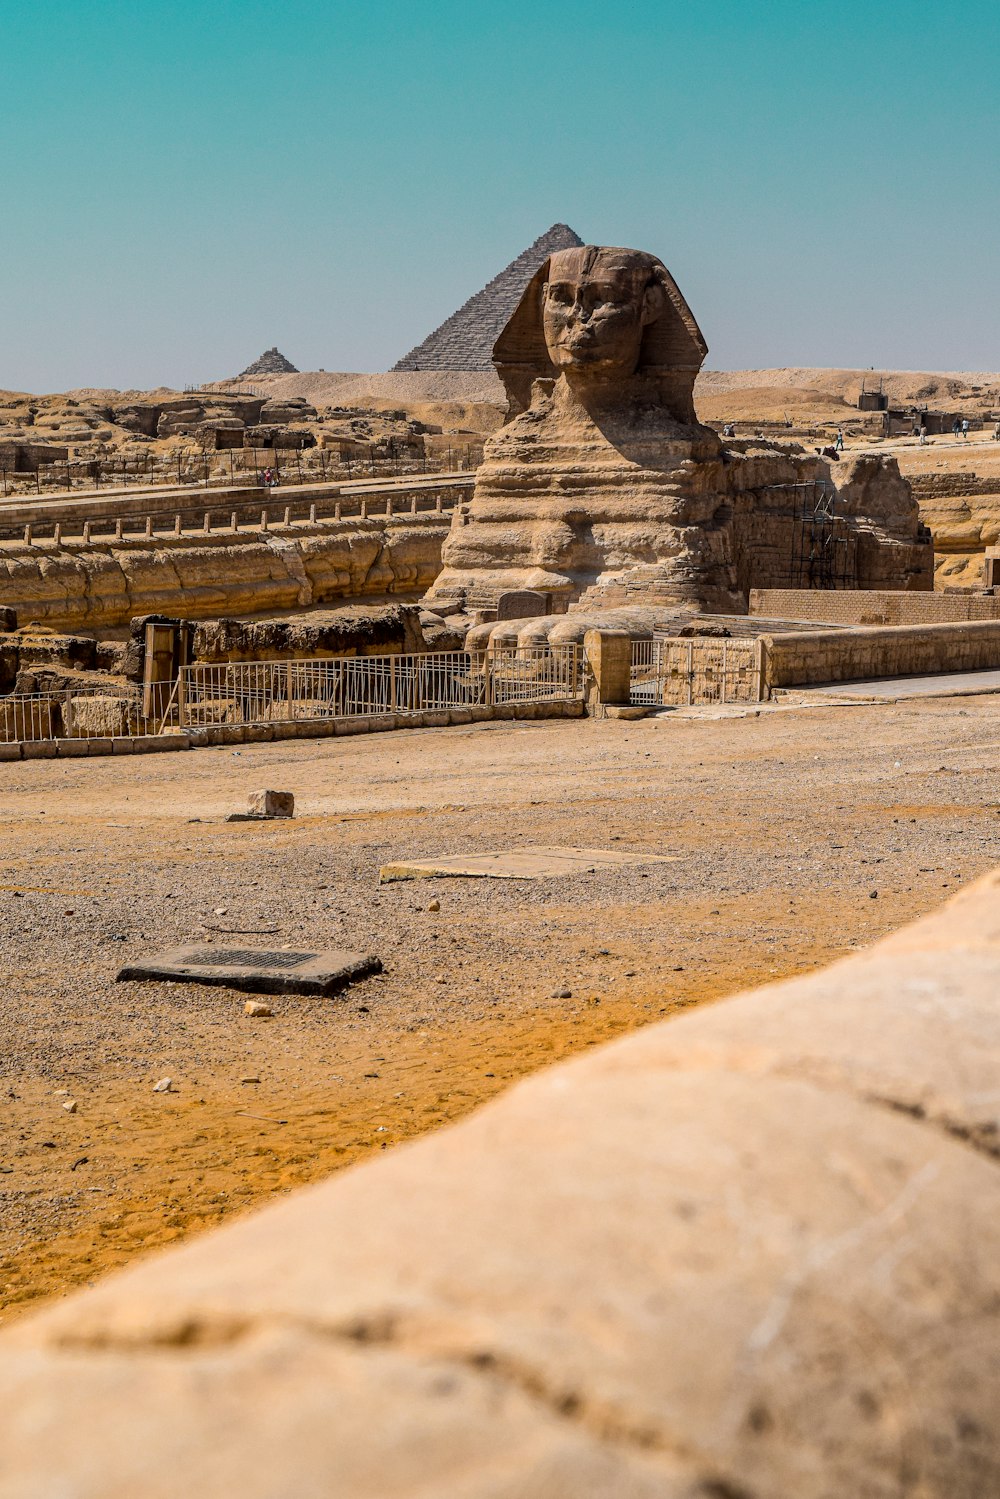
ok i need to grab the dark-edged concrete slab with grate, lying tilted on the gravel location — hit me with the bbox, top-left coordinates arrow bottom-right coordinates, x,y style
118,944 -> 382,995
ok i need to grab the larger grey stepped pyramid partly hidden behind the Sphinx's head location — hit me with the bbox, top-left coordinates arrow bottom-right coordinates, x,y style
393,223 -> 583,370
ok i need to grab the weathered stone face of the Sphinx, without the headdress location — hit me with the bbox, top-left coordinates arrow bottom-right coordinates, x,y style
541,249 -> 664,381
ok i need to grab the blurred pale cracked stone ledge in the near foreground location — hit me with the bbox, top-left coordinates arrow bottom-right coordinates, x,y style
0,875 -> 1000,1499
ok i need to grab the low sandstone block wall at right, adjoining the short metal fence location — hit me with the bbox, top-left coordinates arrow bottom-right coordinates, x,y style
762,621 -> 1000,697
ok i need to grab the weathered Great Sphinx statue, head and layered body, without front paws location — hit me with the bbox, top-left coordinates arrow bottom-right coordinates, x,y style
427,246 -> 933,613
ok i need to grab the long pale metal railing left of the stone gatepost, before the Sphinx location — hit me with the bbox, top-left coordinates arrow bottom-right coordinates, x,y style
162,645 -> 583,732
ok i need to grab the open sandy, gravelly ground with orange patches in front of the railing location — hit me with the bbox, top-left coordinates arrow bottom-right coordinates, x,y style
0,699 -> 1000,1319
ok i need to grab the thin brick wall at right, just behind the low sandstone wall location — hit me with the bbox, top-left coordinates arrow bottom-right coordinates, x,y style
750,588 -> 1000,625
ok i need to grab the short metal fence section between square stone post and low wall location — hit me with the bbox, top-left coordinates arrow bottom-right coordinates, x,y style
630,639 -> 763,708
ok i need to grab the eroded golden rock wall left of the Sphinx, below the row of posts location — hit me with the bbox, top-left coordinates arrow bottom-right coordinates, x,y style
0,514 -> 448,630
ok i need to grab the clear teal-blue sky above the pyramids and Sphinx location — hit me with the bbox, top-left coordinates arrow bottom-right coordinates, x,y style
0,0 -> 1000,390
